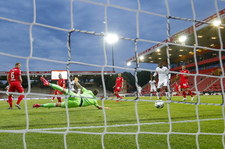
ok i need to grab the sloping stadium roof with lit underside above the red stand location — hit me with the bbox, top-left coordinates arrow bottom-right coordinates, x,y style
127,9 -> 225,67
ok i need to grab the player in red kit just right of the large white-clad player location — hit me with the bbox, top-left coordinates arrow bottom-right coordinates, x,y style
179,65 -> 194,101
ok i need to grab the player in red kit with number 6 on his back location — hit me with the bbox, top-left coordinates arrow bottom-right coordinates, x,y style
7,63 -> 24,109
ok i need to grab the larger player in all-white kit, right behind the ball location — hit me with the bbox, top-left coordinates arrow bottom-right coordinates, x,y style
153,64 -> 170,99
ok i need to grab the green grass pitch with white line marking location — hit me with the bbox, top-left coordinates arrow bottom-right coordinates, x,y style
0,95 -> 224,149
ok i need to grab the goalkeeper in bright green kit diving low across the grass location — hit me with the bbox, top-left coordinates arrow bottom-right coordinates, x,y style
33,77 -> 109,109
